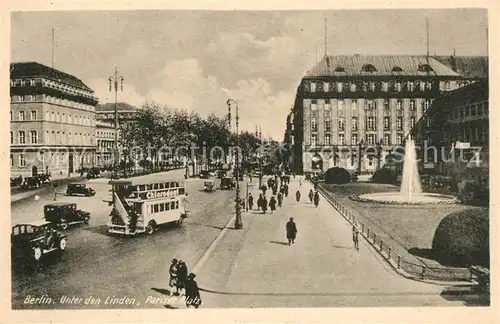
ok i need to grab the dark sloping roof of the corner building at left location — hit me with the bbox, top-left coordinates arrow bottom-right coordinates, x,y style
10,62 -> 94,93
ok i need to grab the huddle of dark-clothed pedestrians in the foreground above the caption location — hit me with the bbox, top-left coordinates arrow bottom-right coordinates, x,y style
169,258 -> 201,308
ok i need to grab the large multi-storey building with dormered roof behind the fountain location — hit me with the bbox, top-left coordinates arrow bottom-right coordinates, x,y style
286,55 -> 463,173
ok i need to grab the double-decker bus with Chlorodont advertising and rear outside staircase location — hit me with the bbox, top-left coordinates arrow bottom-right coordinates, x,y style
108,179 -> 188,235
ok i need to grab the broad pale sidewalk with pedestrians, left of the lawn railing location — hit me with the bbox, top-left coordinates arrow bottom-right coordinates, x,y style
191,178 -> 460,308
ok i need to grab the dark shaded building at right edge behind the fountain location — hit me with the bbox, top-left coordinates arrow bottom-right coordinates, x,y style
410,80 -> 489,182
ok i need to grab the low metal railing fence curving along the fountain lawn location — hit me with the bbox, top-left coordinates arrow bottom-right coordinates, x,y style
318,185 -> 471,281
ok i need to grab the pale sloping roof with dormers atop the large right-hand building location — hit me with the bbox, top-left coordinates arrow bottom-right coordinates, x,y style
306,55 -> 460,77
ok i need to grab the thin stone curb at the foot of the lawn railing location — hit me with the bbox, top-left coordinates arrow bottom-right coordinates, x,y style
309,181 -> 476,286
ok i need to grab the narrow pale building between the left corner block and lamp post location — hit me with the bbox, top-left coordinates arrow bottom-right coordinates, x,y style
95,121 -> 116,167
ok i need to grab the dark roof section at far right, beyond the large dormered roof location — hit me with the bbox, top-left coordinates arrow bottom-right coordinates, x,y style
434,55 -> 488,79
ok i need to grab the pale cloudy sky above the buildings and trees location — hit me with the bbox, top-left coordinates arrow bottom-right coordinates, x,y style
11,9 -> 488,140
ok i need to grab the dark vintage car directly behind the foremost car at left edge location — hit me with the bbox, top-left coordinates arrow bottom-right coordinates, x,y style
43,203 -> 90,230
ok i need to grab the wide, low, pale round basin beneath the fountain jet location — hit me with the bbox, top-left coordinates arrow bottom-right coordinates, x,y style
349,192 -> 457,205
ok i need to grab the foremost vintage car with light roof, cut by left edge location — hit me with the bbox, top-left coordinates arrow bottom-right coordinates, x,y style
10,219 -> 67,262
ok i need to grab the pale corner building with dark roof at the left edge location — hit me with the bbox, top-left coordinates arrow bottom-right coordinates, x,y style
10,62 -> 98,176
